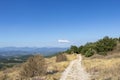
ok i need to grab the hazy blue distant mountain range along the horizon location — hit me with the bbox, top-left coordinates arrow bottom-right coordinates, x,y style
0,47 -> 68,57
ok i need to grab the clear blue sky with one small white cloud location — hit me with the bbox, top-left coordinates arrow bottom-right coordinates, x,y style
0,0 -> 120,47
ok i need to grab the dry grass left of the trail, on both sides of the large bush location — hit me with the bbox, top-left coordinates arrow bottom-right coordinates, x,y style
0,54 -> 76,80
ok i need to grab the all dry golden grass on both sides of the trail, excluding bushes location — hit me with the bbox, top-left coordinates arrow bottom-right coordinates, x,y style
0,53 -> 120,80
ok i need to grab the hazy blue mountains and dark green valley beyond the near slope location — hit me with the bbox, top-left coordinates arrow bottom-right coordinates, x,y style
0,47 -> 67,69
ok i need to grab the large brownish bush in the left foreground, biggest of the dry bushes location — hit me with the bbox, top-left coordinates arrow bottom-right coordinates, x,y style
20,55 -> 47,78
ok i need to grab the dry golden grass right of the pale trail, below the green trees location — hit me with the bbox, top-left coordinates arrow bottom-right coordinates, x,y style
83,54 -> 120,80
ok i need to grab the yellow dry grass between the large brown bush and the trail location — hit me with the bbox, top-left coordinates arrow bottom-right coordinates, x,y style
46,54 -> 76,80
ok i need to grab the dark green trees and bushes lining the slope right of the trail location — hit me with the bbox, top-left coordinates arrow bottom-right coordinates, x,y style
65,36 -> 120,57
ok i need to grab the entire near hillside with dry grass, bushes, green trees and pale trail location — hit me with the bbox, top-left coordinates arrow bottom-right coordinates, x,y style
0,37 -> 120,80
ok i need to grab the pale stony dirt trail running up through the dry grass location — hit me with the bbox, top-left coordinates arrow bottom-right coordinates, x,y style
60,55 -> 90,80
